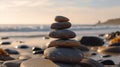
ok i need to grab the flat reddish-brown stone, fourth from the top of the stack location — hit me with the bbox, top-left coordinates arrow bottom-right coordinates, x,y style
48,40 -> 80,47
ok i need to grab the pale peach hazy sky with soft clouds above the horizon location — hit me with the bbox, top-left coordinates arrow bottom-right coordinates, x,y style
0,0 -> 120,24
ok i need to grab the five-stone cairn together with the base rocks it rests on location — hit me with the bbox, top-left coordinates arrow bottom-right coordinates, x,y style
20,16 -> 103,67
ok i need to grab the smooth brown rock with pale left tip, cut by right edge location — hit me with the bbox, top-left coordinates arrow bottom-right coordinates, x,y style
98,46 -> 120,55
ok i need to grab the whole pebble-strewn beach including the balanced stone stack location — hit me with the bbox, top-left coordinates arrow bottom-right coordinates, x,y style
0,16 -> 120,67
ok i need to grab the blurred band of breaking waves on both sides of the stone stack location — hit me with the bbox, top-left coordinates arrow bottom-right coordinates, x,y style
0,25 -> 120,32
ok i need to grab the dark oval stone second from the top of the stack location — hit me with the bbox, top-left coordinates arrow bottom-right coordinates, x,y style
51,22 -> 71,29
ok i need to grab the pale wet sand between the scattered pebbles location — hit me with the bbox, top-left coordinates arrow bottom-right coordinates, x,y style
0,37 -> 120,67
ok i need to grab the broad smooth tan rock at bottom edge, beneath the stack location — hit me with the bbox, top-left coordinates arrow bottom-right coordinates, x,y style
20,58 -> 81,67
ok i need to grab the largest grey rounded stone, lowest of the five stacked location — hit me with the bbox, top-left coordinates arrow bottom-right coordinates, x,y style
44,47 -> 83,63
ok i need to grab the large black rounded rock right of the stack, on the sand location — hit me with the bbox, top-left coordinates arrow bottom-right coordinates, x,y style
79,36 -> 104,46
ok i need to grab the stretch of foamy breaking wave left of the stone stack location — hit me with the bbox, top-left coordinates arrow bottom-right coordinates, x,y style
0,25 -> 50,32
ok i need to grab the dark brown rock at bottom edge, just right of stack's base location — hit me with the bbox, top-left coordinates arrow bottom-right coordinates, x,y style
80,58 -> 104,67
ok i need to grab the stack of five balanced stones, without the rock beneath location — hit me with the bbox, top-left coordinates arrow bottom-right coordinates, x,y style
44,16 -> 83,67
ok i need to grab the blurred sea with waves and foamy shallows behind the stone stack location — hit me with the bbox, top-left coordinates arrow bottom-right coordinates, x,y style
0,24 -> 120,38
